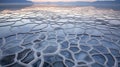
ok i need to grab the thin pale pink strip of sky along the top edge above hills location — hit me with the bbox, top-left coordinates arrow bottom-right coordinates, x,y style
30,0 -> 115,2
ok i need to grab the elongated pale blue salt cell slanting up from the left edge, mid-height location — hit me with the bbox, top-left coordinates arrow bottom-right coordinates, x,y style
1,40 -> 21,50
